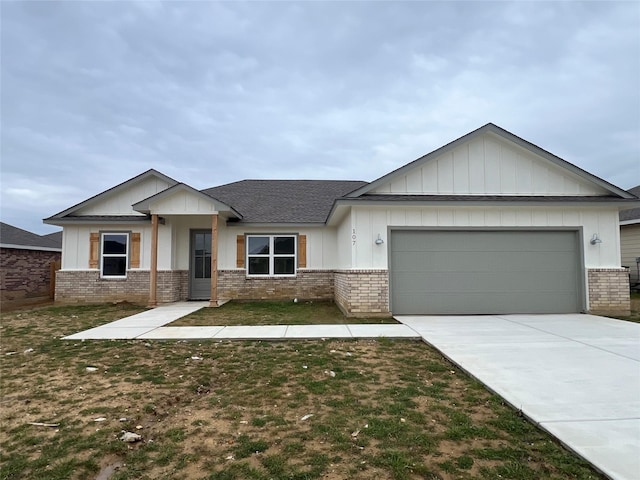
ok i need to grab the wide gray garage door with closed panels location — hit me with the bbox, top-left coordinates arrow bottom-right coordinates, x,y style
389,230 -> 582,315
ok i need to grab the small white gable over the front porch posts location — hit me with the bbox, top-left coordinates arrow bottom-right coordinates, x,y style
133,183 -> 240,217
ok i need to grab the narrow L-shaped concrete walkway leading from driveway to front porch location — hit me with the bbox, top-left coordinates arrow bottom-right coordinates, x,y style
64,302 -> 420,340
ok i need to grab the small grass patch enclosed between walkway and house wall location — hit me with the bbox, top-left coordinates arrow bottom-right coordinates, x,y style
167,301 -> 398,327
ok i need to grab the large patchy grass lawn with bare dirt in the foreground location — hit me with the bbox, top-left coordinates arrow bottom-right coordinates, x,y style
0,305 -> 604,480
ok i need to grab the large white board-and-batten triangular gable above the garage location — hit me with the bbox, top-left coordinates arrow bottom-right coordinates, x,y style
348,123 -> 631,198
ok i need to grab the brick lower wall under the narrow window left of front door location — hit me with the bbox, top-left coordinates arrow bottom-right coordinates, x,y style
56,270 -> 189,304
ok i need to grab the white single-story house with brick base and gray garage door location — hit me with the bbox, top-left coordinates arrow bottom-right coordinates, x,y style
44,124 -> 640,315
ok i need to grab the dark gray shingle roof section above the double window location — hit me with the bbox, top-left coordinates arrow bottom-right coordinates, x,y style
202,180 -> 367,223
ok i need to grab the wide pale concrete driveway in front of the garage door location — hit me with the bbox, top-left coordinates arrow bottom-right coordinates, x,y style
396,314 -> 640,480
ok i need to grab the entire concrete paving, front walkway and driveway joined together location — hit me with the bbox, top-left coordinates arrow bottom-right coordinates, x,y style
65,302 -> 640,480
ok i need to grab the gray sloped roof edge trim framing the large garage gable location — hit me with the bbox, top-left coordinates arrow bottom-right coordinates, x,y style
348,123 -> 633,198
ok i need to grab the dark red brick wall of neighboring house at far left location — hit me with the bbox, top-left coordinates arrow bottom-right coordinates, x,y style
0,248 -> 60,306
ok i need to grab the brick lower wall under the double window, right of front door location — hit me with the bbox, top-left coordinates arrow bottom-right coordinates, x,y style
218,270 -> 333,300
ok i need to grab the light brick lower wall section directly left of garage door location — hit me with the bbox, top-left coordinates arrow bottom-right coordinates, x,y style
334,270 -> 390,317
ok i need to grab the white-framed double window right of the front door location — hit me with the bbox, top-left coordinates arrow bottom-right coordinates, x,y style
247,235 -> 296,276
